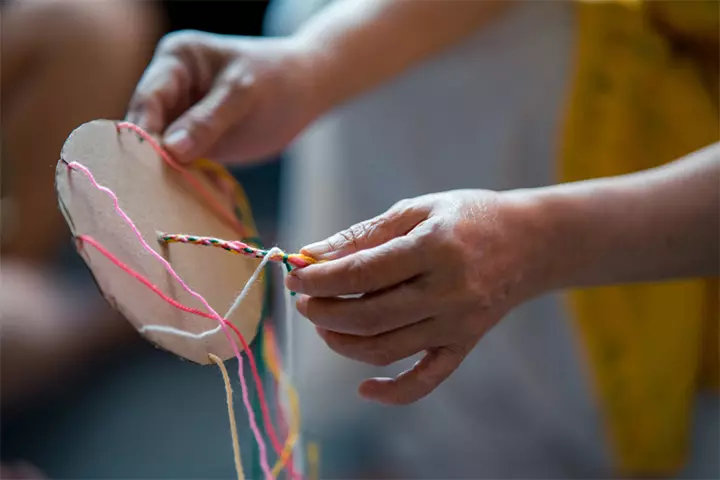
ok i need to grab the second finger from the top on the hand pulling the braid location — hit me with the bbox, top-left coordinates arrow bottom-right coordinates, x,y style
286,233 -> 430,297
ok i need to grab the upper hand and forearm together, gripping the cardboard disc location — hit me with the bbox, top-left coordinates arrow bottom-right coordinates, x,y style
127,0 -> 512,163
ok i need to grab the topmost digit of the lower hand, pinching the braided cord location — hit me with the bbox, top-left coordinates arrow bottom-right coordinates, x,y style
300,202 -> 427,260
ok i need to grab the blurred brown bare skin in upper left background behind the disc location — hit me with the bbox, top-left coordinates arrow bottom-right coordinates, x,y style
0,0 -> 157,263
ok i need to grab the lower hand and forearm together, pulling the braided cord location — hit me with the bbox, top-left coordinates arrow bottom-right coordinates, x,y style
287,144 -> 720,404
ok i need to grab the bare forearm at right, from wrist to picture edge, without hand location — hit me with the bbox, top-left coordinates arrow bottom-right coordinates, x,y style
529,144 -> 720,287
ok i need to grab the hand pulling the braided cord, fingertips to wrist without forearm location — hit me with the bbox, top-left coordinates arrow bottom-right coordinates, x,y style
287,190 -> 544,404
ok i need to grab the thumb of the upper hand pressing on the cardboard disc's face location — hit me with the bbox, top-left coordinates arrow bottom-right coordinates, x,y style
163,74 -> 250,163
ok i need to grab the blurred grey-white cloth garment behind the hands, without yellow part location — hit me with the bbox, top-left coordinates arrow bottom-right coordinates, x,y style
269,0 -> 609,478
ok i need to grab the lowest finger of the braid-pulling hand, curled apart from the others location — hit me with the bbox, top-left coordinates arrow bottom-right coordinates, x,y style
359,346 -> 466,405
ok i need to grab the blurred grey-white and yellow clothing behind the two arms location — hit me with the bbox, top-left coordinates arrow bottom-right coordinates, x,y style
272,1 -> 720,478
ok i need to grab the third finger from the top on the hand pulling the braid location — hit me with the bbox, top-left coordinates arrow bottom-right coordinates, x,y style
296,281 -> 439,337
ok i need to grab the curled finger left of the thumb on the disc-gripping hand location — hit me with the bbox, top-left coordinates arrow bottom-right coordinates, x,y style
125,55 -> 191,134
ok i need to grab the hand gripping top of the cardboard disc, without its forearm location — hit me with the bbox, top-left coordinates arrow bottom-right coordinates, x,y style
127,31 -> 320,163
